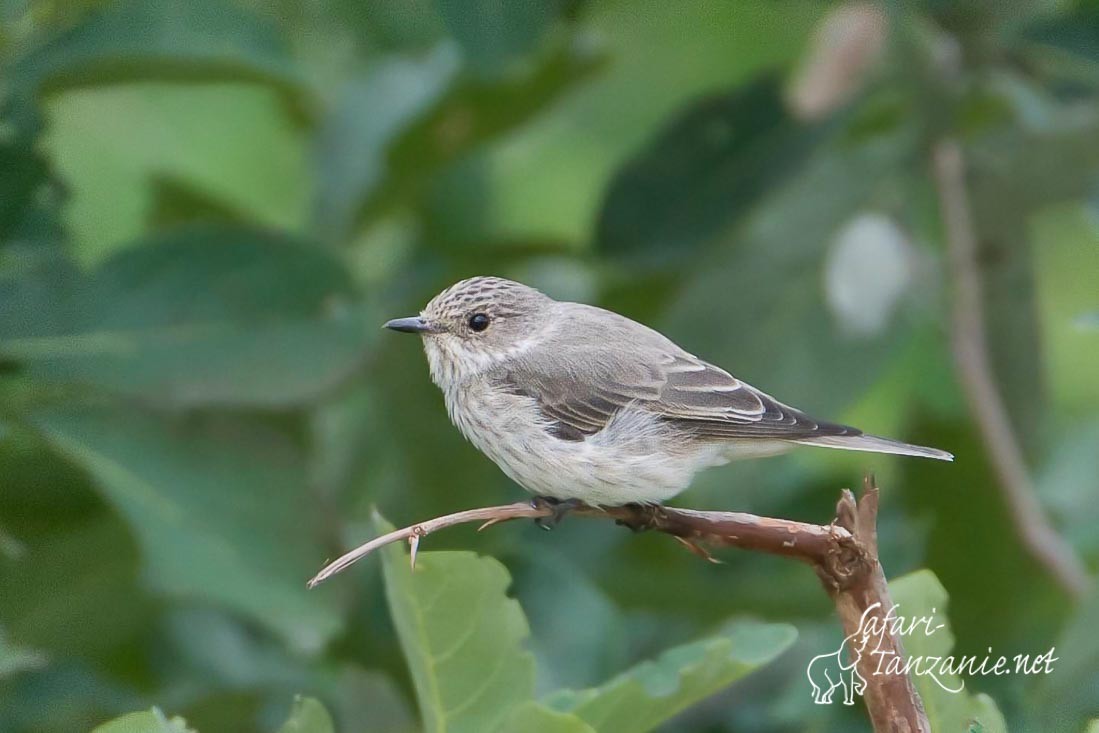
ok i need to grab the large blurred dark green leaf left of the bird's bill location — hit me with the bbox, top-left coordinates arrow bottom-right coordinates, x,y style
0,226 -> 376,407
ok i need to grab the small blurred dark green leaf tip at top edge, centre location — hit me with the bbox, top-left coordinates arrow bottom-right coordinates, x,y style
436,0 -> 562,76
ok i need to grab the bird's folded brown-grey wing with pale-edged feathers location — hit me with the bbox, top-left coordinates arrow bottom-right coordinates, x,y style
496,337 -> 859,440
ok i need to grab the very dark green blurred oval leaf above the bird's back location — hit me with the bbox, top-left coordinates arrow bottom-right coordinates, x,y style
597,75 -> 822,258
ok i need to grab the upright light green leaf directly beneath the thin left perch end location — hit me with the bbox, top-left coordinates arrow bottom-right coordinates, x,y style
378,520 -> 534,733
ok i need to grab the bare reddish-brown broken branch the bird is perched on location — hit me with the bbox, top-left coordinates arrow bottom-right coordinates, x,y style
309,479 -> 931,733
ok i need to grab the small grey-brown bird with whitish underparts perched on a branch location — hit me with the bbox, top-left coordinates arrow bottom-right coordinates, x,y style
386,277 -> 954,506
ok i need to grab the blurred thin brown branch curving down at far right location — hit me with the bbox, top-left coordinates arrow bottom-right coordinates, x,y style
932,138 -> 1090,598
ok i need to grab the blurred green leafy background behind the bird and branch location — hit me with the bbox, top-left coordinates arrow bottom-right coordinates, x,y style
0,0 -> 1099,733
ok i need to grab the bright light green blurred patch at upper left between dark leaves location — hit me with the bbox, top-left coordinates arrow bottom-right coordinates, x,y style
42,82 -> 312,264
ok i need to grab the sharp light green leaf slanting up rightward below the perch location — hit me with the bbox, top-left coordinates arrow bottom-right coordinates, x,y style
548,621 -> 797,733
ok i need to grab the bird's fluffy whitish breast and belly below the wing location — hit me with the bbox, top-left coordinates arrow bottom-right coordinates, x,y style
445,386 -> 742,506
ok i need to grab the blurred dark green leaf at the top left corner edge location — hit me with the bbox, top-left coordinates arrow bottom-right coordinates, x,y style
11,0 -> 299,101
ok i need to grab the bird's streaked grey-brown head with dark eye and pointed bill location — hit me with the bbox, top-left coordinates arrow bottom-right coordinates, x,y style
385,277 -> 556,387
